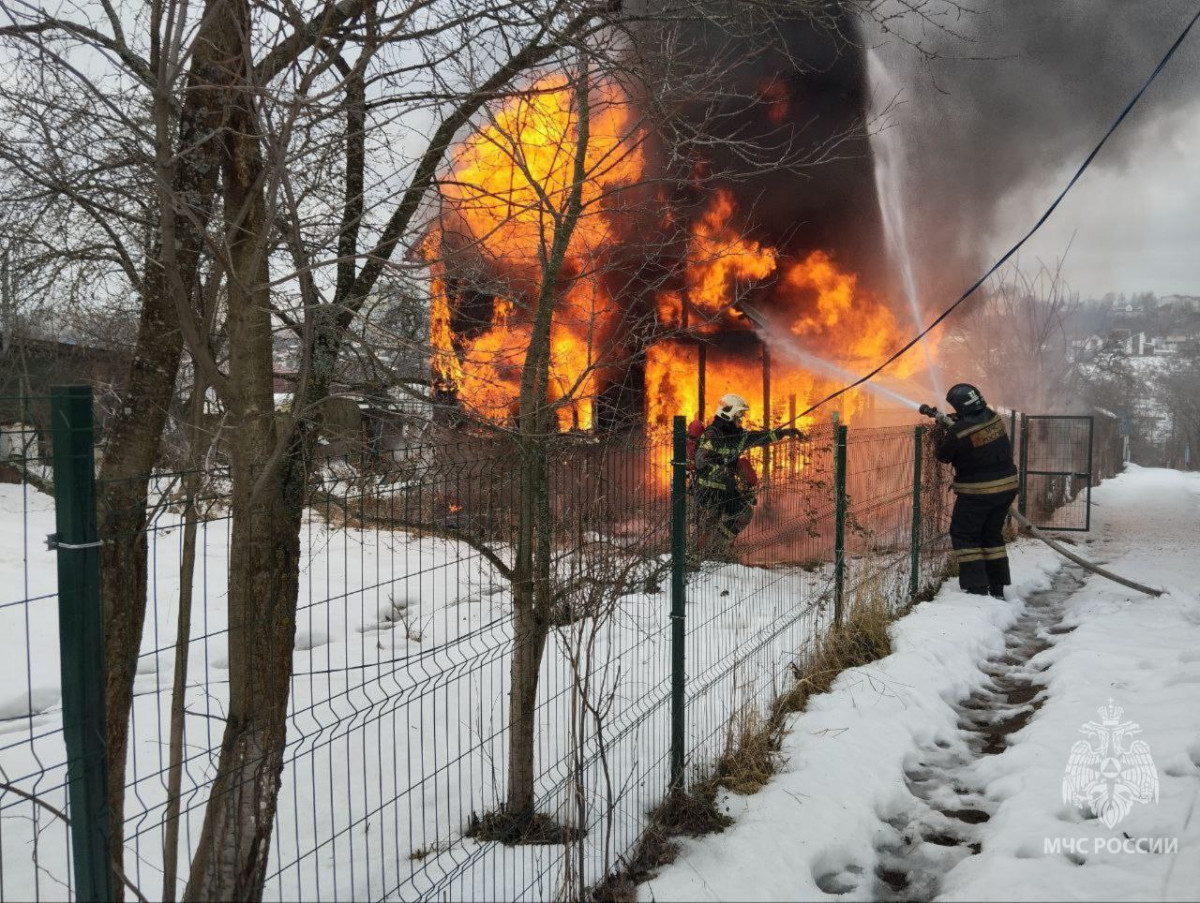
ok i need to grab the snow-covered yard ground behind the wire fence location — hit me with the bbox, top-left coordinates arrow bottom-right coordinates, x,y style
0,475 -> 854,901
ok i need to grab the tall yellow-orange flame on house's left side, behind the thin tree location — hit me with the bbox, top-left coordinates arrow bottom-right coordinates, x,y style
426,77 -> 643,430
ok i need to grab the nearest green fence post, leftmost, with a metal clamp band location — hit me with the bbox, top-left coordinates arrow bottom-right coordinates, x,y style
50,385 -> 114,903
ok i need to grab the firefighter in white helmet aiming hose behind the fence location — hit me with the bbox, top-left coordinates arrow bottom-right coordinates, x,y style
694,394 -> 803,561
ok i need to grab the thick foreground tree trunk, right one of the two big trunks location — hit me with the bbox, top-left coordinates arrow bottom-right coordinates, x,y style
184,7 -> 305,901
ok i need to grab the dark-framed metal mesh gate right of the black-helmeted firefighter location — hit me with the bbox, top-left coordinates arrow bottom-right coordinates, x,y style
1016,414 -> 1096,532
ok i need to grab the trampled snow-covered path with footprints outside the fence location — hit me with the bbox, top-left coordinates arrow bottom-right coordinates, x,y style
641,466 -> 1200,901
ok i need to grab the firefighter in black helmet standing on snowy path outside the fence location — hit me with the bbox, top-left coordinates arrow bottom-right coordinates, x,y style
937,383 -> 1018,599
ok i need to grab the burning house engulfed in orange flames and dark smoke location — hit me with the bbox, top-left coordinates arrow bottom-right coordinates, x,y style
424,10 -> 921,430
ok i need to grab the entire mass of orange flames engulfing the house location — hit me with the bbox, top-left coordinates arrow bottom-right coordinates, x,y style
426,72 -> 926,431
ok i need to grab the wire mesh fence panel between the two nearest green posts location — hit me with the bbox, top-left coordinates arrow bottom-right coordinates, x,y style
93,441 -> 686,899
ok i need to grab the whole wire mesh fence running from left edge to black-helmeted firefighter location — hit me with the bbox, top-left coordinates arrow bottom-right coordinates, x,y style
0,403 -> 947,899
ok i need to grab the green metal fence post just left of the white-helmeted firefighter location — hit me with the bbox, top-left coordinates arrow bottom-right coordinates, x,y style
671,417 -> 688,790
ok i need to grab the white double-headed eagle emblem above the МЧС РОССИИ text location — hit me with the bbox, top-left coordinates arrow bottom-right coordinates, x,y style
1062,699 -> 1158,830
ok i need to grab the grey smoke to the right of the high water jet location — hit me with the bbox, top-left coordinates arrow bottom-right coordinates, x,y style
866,0 -> 1200,307
